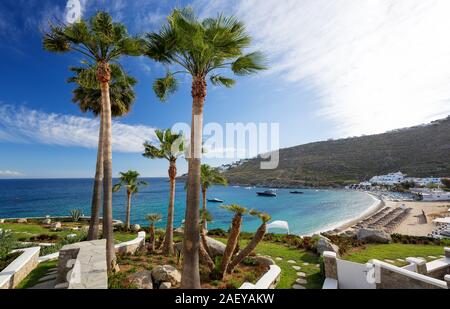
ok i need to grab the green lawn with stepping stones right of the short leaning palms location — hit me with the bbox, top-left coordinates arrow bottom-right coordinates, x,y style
216,238 -> 323,289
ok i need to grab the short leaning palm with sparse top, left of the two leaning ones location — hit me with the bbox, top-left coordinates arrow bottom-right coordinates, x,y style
220,205 -> 248,277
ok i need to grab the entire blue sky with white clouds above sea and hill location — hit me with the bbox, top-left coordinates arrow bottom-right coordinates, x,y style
0,0 -> 450,178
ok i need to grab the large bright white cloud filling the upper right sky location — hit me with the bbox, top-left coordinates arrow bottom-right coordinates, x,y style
194,0 -> 450,136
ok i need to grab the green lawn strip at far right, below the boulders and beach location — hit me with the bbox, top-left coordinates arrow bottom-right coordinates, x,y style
343,244 -> 444,266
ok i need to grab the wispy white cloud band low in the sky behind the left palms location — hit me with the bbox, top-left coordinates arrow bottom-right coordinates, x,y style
0,105 -> 155,153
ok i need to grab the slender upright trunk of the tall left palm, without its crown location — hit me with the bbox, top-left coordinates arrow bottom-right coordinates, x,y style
97,62 -> 117,271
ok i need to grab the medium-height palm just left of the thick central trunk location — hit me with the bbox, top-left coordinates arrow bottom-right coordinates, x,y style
143,129 -> 185,255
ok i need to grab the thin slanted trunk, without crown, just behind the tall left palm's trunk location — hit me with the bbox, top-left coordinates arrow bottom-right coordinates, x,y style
87,110 -> 104,240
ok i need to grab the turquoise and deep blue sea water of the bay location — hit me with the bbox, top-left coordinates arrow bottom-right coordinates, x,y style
0,178 -> 374,235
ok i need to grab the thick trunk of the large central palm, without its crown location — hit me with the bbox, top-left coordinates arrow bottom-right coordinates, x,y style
181,76 -> 206,289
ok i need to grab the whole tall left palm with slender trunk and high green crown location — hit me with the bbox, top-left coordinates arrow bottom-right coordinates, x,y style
43,12 -> 142,271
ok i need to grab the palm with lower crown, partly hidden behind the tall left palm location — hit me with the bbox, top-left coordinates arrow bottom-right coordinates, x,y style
68,64 -> 137,240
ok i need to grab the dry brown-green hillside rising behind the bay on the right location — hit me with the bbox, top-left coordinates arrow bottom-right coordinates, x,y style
224,117 -> 450,187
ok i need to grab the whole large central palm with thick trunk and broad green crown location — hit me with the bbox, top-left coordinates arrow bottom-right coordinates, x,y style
144,9 -> 265,289
